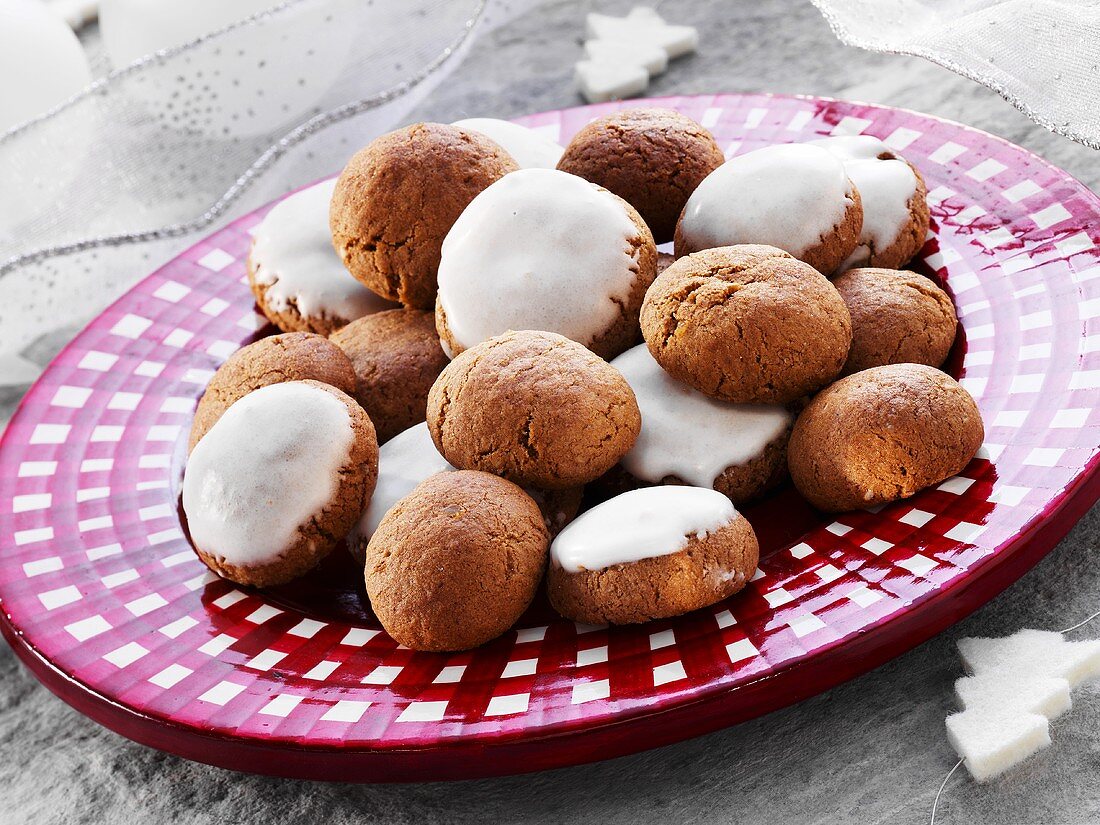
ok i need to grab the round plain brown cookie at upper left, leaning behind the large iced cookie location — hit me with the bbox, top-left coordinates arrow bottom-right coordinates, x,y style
329,123 -> 519,309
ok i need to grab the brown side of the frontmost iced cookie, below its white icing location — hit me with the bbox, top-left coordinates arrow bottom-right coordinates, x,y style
547,515 -> 760,625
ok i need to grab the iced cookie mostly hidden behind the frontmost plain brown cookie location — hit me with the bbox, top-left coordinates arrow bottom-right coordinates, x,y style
349,421 -> 583,564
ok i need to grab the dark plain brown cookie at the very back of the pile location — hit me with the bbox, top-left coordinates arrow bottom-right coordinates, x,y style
558,109 -> 726,243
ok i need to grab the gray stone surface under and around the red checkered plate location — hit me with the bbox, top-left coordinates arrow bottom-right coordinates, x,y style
0,0 -> 1100,825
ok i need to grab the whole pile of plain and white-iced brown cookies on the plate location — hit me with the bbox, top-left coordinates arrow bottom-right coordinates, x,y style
183,109 -> 983,650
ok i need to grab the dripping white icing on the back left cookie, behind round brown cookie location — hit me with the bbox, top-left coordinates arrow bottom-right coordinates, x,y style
250,178 -> 397,321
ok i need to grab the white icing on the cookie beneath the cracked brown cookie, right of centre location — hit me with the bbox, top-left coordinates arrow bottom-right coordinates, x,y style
612,344 -> 791,487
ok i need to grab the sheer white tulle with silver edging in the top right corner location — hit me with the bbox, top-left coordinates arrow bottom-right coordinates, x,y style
813,0 -> 1100,149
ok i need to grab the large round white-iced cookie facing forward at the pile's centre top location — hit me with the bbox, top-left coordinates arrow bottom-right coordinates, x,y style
436,169 -> 657,358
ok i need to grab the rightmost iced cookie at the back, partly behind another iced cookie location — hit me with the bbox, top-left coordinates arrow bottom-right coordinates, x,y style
812,134 -> 928,270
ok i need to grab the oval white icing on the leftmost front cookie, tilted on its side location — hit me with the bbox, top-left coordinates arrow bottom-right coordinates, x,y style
184,382 -> 354,565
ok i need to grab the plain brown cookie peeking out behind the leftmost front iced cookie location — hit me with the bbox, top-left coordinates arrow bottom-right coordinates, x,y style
187,332 -> 355,452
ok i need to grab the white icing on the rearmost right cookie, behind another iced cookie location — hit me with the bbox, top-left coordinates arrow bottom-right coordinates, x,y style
811,134 -> 916,270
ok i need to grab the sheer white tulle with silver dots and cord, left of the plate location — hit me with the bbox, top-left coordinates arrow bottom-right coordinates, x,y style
0,0 -> 537,363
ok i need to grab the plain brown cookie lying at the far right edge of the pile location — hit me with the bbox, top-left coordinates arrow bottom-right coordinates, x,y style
788,364 -> 985,513
